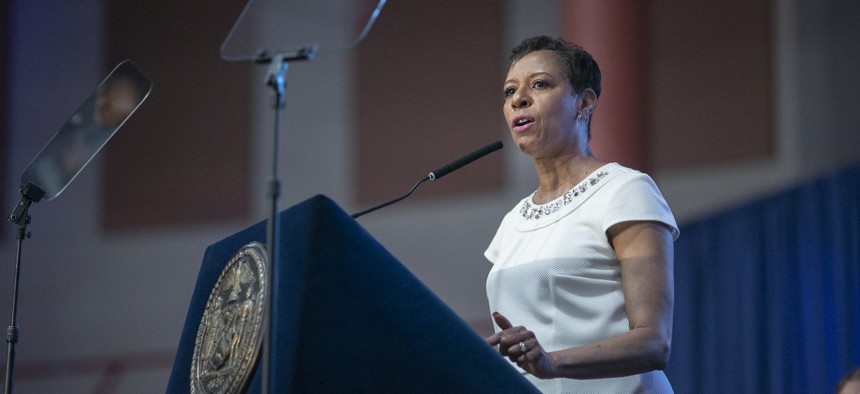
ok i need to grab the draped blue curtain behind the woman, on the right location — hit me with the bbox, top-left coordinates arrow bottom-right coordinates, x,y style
666,162 -> 860,394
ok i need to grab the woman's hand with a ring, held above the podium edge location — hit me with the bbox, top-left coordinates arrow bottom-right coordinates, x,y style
485,312 -> 556,379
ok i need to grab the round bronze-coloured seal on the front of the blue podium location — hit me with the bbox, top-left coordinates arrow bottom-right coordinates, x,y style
191,242 -> 268,393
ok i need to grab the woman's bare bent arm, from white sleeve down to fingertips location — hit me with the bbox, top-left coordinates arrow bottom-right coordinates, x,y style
487,221 -> 674,379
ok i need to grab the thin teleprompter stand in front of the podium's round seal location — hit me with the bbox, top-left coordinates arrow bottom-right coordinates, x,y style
254,45 -> 316,394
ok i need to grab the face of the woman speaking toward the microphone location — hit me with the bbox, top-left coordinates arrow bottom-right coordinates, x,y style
503,50 -> 587,158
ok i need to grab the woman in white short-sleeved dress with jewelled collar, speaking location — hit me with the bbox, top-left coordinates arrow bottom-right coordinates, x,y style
485,36 -> 678,393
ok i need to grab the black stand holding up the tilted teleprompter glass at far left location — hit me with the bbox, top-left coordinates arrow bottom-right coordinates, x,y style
5,182 -> 45,394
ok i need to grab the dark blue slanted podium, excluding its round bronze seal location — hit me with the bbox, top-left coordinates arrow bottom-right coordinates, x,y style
167,196 -> 538,393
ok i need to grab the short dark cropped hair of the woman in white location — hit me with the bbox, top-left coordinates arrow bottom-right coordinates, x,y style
508,36 -> 600,97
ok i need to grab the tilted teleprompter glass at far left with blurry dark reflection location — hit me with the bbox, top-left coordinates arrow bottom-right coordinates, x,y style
21,60 -> 152,200
